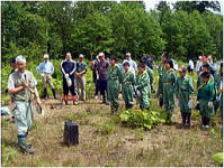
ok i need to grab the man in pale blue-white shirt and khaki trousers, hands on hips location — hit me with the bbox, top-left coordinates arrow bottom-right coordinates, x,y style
36,54 -> 56,99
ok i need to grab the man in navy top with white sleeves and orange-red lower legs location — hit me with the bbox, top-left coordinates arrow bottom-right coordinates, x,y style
61,52 -> 78,105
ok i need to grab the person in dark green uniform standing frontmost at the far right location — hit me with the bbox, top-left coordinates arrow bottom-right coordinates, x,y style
198,72 -> 215,128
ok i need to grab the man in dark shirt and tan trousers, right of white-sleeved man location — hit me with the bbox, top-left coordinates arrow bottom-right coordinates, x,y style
75,54 -> 87,101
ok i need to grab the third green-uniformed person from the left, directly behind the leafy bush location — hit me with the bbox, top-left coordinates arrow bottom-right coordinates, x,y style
135,63 -> 150,110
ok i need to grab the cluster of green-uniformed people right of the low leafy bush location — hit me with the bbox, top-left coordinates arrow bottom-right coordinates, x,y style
158,55 -> 223,128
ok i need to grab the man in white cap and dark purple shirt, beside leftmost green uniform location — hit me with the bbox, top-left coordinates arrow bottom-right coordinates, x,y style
97,52 -> 109,105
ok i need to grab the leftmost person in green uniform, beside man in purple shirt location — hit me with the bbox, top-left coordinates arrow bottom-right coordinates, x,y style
108,57 -> 121,114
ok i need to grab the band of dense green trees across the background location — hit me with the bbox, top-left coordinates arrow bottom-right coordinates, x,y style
1,1 -> 223,62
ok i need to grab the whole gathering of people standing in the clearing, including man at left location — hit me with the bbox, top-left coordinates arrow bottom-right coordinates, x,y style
3,52 -> 223,154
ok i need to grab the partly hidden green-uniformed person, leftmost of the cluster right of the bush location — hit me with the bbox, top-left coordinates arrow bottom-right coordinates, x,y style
157,54 -> 168,107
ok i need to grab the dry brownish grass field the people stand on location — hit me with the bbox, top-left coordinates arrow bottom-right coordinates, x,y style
1,59 -> 223,167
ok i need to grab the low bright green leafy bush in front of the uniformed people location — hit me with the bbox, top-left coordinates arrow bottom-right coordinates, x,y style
119,109 -> 165,130
